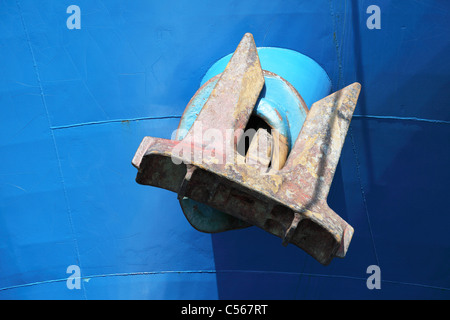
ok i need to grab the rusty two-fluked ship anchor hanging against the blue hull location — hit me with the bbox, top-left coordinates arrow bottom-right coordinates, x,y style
132,33 -> 361,265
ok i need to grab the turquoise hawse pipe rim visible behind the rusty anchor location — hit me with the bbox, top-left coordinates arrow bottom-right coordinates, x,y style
175,47 -> 331,233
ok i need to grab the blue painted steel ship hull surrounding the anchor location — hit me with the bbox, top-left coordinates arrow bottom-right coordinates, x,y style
0,0 -> 450,299
